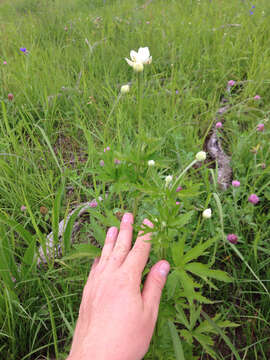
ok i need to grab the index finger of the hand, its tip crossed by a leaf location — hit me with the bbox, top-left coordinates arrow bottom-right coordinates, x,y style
123,219 -> 154,277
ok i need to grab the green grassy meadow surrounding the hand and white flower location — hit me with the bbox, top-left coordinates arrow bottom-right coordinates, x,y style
0,0 -> 270,360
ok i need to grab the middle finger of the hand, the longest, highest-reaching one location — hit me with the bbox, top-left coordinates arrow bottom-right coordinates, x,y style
110,213 -> 133,267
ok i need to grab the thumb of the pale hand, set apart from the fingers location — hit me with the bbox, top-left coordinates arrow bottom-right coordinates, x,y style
142,260 -> 170,322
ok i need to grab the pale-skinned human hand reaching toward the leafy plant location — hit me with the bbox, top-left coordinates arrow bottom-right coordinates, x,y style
67,213 -> 170,360
